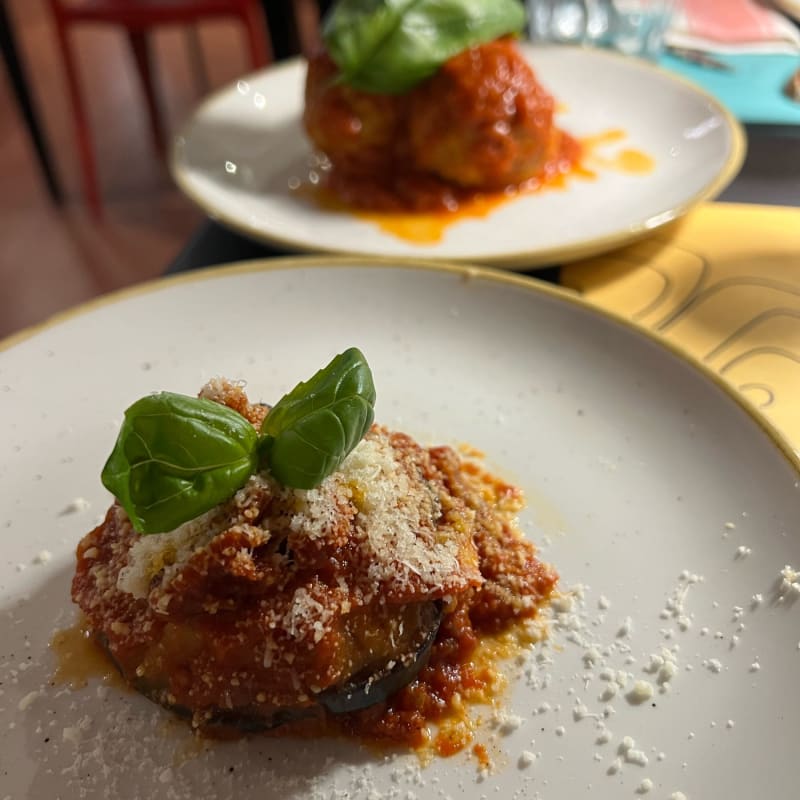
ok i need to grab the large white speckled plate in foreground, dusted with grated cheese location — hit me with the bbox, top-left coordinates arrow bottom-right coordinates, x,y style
0,259 -> 800,800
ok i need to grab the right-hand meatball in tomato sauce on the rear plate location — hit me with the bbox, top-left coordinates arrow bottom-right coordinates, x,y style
408,39 -> 554,189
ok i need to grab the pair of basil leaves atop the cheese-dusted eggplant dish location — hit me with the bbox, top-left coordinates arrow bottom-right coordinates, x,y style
101,348 -> 375,533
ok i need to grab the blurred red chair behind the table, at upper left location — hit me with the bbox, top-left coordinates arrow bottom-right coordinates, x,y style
50,0 -> 272,218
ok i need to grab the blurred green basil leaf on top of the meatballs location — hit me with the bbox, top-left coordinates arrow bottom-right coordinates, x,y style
322,0 -> 525,94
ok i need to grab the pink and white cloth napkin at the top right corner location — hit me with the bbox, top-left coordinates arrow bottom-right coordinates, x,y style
665,0 -> 800,53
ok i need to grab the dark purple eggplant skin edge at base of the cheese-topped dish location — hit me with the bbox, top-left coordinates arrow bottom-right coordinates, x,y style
96,601 -> 443,734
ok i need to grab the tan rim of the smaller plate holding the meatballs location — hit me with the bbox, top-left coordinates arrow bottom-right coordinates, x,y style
167,48 -> 747,270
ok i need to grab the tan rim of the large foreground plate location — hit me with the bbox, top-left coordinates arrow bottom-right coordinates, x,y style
0,255 -> 800,479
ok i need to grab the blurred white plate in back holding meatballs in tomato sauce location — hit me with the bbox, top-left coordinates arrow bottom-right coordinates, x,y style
171,45 -> 745,268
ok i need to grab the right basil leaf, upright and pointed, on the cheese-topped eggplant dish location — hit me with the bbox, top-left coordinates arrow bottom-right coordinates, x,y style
261,347 -> 375,489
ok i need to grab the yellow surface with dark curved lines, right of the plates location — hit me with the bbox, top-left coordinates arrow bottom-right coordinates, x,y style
561,203 -> 800,453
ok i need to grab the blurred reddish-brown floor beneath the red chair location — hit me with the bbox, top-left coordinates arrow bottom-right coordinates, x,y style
0,0 -> 266,337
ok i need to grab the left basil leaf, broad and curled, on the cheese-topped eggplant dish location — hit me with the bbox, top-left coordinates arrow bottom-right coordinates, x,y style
101,392 -> 258,533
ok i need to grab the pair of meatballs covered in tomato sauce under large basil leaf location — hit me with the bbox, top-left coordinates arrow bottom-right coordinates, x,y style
304,38 -> 565,212
